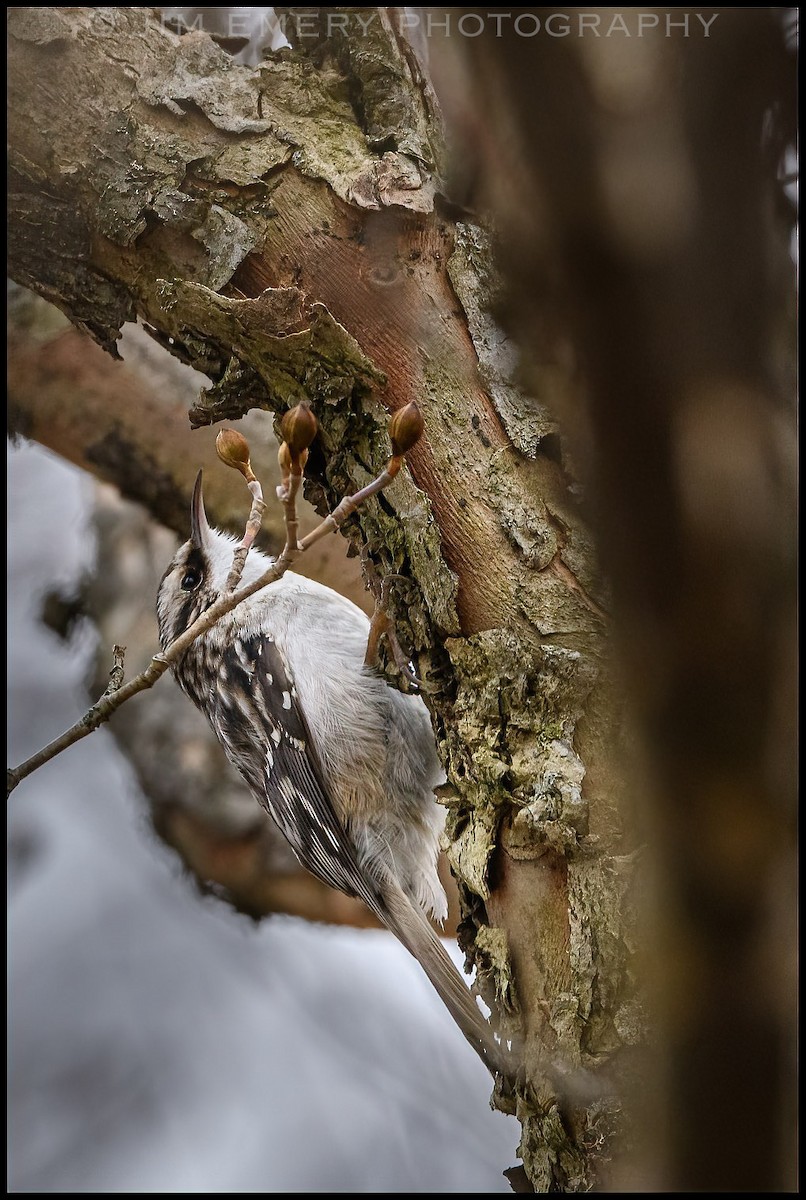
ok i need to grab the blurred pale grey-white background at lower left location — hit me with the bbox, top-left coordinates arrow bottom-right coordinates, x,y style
8,444 -> 518,1193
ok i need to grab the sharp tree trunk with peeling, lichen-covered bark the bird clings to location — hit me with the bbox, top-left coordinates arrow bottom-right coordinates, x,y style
10,8 -> 643,1190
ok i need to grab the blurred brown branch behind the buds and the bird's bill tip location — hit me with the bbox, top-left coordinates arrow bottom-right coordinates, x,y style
6,284 -> 372,600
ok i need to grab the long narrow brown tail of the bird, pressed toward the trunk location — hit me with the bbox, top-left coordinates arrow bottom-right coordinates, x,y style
378,878 -> 513,1076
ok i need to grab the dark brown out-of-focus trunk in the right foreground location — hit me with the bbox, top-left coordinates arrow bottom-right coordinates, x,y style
443,8 -> 796,1192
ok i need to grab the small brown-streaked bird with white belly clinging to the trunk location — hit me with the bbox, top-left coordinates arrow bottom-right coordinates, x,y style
156,472 -> 509,1076
